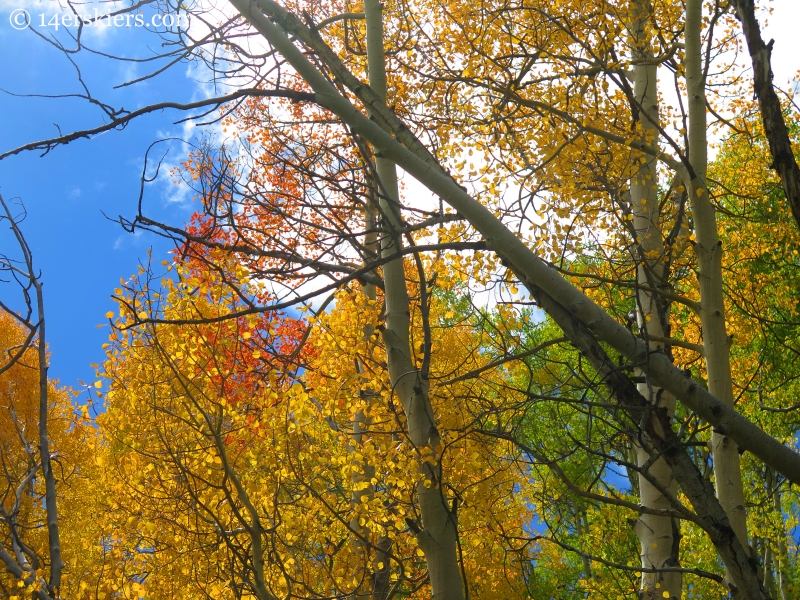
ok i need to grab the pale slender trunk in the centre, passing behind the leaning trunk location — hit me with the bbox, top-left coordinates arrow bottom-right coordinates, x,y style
364,0 -> 464,600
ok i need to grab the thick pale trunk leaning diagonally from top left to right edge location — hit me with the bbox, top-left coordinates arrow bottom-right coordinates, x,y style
229,0 -> 800,484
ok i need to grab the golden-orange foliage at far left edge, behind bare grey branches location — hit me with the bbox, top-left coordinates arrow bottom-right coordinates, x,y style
0,313 -> 103,599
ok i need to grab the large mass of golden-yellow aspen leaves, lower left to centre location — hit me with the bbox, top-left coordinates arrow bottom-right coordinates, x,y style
79,241 -> 564,599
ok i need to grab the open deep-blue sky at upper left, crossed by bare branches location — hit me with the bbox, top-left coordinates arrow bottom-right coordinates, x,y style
0,10 -> 199,394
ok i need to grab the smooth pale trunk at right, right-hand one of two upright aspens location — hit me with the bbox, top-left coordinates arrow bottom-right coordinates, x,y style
686,0 -> 749,583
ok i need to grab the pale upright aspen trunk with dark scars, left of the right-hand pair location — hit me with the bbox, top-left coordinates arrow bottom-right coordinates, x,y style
630,0 -> 683,600
